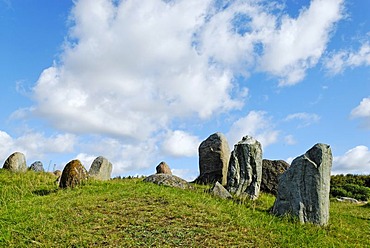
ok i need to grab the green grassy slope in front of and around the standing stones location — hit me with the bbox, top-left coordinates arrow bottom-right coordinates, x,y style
0,170 -> 370,247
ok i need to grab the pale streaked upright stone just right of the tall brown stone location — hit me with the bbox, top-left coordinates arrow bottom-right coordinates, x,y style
227,136 -> 262,199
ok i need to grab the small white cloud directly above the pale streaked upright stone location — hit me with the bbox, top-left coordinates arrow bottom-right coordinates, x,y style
226,111 -> 279,147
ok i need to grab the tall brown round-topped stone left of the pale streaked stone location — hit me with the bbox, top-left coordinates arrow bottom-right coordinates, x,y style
195,133 -> 230,185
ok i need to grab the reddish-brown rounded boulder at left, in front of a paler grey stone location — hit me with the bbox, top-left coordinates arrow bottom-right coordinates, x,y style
59,159 -> 87,188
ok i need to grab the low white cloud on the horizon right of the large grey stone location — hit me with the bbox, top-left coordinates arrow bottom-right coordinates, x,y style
332,146 -> 370,174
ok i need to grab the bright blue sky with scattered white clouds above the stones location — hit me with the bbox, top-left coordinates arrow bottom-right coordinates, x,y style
0,0 -> 370,180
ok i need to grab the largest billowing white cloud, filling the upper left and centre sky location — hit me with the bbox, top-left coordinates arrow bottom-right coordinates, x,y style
33,0 -> 243,140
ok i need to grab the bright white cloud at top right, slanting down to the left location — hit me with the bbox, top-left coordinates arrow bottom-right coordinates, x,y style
261,0 -> 343,86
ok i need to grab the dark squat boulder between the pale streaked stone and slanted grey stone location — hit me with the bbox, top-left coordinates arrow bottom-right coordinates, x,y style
260,159 -> 289,196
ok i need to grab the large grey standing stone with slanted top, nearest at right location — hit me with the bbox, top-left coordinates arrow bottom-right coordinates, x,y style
272,144 -> 332,225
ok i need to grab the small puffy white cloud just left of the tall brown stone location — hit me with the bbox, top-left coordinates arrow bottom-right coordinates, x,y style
162,130 -> 200,157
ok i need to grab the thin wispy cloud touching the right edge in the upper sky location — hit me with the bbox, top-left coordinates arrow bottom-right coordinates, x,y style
324,42 -> 370,75
